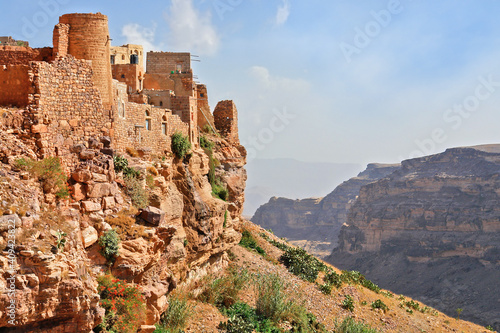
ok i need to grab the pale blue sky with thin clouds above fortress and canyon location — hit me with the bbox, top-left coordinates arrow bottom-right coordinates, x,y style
0,0 -> 500,164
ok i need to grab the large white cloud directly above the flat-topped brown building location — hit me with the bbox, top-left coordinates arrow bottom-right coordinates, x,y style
165,0 -> 220,55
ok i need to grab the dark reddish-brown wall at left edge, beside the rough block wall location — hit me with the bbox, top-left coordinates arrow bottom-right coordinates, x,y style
0,65 -> 31,108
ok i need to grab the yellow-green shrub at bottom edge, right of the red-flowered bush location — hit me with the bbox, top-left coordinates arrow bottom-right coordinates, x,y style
160,295 -> 193,333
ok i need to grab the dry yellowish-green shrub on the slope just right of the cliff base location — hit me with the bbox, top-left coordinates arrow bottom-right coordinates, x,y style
198,266 -> 250,308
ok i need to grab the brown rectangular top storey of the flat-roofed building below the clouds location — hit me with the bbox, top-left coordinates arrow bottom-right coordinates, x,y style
146,52 -> 191,74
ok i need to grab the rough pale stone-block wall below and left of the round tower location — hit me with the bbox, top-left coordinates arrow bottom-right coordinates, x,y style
26,56 -> 111,165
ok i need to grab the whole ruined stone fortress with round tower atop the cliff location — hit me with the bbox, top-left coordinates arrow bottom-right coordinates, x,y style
0,13 -> 237,167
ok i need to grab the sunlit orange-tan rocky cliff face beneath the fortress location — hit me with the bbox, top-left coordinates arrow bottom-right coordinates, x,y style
0,111 -> 246,332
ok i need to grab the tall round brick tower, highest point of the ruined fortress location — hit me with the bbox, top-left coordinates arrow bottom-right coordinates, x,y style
58,13 -> 113,110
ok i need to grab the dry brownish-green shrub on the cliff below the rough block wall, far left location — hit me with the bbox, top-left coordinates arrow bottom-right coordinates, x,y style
14,157 -> 69,199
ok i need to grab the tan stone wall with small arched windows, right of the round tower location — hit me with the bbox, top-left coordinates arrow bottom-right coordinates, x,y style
113,83 -> 189,155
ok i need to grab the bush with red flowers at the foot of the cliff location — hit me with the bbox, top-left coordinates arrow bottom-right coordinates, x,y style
97,275 -> 146,333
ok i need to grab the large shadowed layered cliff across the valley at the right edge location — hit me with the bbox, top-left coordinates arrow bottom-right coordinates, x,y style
328,145 -> 500,329
